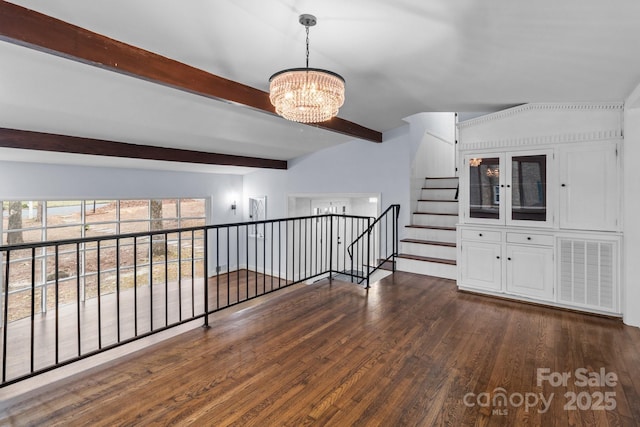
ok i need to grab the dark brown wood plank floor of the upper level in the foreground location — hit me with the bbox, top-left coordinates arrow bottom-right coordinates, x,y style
0,272 -> 640,426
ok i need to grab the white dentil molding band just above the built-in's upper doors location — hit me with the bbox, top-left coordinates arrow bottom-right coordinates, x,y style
459,129 -> 623,151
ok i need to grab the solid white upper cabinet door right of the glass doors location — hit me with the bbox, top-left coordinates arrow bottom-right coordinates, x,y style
558,141 -> 620,231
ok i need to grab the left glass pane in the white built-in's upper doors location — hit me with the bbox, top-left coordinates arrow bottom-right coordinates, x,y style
467,156 -> 504,222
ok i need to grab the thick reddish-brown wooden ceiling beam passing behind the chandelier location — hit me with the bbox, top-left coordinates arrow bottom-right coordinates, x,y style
0,1 -> 382,142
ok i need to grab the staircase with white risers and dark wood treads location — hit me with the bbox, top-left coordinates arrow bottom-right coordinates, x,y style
397,177 -> 458,280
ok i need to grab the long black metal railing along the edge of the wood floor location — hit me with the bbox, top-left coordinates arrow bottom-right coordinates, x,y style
0,209 -> 399,387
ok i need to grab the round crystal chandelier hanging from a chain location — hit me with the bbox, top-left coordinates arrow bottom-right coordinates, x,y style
269,14 -> 344,123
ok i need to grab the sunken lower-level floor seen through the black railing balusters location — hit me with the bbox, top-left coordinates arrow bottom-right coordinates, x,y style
0,270 -> 290,380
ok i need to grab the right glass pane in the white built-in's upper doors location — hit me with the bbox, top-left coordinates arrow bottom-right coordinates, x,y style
508,154 -> 547,222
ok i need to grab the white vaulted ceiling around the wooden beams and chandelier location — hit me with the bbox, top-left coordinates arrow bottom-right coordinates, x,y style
0,0 -> 640,171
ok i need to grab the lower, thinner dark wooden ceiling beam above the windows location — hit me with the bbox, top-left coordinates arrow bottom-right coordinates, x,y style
0,128 -> 287,169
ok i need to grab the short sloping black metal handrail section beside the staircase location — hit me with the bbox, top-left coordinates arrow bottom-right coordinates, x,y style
347,205 -> 400,287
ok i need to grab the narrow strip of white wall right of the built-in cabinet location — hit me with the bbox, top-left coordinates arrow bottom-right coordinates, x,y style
622,86 -> 640,327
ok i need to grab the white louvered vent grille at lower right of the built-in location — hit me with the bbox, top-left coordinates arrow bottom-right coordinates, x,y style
558,239 -> 618,311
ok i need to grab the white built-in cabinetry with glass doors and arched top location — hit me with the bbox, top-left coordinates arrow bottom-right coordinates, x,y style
457,104 -> 622,315
